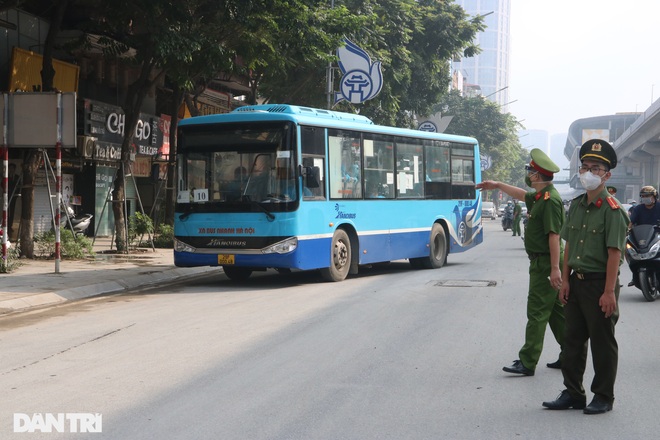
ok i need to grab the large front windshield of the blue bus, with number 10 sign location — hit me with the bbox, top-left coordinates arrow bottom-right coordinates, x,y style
177,123 -> 297,212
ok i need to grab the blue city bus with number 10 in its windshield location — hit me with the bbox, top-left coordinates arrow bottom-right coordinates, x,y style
174,104 -> 483,281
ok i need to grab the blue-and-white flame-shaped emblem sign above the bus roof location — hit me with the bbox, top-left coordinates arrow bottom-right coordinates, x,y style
335,38 -> 383,104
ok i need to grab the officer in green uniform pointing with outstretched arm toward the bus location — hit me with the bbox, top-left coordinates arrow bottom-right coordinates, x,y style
477,148 -> 566,376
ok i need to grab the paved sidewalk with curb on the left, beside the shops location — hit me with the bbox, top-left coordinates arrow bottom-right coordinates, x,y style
0,238 -> 220,315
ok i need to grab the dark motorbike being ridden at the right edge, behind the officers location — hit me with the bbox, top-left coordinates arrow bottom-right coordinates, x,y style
626,225 -> 660,301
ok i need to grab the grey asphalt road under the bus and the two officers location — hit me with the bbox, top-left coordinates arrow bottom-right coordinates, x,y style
0,220 -> 660,440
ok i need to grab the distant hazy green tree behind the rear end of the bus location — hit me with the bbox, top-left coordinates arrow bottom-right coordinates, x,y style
433,90 -> 528,186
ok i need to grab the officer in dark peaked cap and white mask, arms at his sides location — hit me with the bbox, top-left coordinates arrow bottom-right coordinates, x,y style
543,139 -> 628,414
